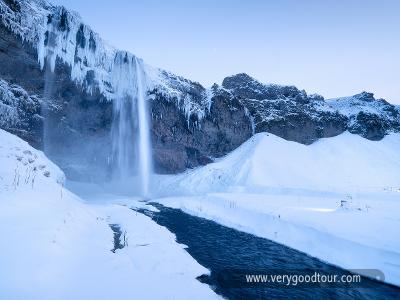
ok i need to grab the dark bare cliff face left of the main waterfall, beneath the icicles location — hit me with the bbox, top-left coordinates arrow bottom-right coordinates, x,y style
0,21 -> 112,178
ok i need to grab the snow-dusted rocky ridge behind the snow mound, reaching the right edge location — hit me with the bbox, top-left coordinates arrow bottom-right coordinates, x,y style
222,74 -> 400,144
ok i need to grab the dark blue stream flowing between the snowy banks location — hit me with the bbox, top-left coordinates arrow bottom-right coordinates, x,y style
141,204 -> 400,299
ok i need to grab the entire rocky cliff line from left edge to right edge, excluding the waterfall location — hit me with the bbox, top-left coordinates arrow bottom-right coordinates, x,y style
0,0 -> 400,180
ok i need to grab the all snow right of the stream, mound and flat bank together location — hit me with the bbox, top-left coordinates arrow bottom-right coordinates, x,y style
152,133 -> 400,285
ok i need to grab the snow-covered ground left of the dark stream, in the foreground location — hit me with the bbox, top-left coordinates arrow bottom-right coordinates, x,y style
0,130 -> 217,300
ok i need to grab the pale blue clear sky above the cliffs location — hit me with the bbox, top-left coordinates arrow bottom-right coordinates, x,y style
50,0 -> 400,104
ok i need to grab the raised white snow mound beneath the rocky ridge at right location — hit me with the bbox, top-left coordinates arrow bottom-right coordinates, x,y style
162,132 -> 400,194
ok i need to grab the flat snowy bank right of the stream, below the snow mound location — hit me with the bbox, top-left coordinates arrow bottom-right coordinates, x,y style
155,193 -> 400,285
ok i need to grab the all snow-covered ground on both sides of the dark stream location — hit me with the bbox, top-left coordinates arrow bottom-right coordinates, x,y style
0,126 -> 400,299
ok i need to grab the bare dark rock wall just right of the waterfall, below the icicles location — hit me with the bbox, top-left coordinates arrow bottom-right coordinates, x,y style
151,88 -> 252,173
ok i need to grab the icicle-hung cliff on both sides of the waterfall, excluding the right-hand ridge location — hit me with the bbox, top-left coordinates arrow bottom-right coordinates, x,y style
0,0 -> 252,179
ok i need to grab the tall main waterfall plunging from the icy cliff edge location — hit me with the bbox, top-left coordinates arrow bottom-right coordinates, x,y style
112,52 -> 152,197
